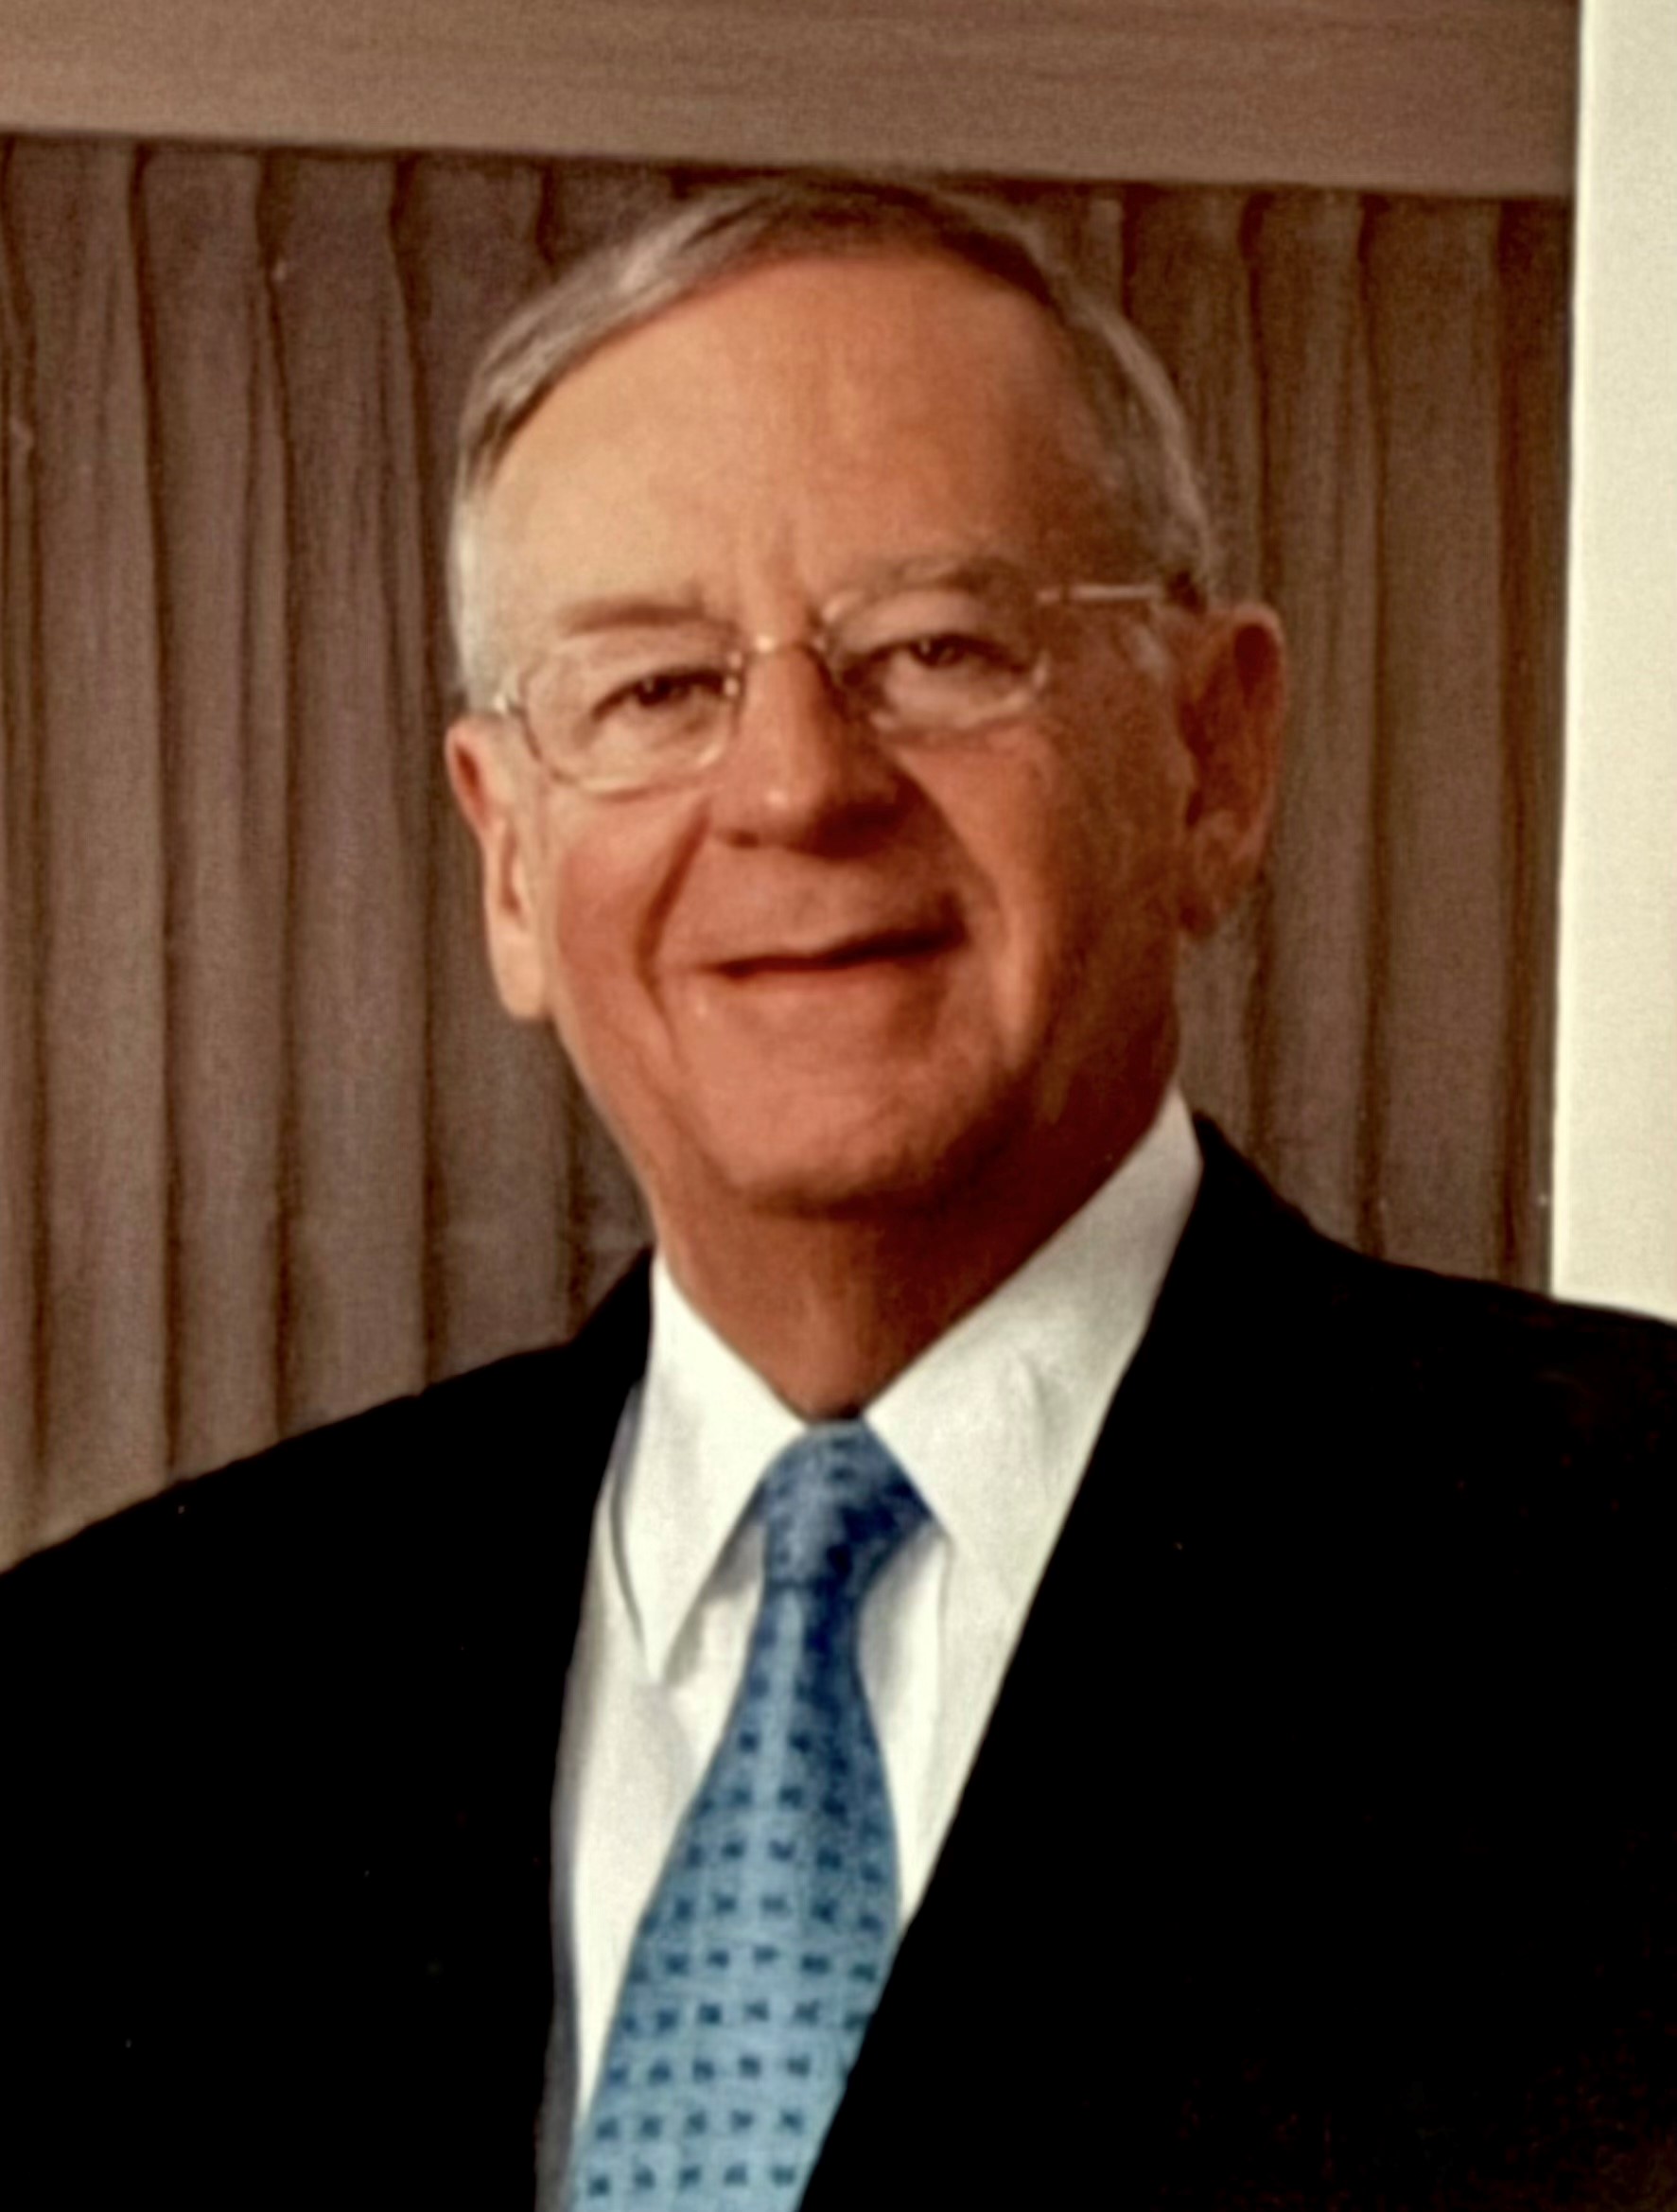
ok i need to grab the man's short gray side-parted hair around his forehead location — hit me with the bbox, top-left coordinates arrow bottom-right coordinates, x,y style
449,177 -> 1216,703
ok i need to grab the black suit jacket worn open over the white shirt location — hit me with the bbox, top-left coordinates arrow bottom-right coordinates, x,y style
0,1131 -> 1677,2212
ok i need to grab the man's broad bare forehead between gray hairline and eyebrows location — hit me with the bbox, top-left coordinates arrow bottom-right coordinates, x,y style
468,253 -> 1100,645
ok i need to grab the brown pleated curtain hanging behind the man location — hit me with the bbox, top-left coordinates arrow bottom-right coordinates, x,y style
0,139 -> 1568,1555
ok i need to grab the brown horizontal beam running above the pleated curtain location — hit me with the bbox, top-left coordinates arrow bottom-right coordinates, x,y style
0,0 -> 1578,197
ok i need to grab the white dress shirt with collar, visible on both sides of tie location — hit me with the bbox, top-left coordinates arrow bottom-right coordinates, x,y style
553,1091 -> 1201,2110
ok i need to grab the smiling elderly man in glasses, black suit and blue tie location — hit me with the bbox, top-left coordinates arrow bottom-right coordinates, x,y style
0,184 -> 1677,2212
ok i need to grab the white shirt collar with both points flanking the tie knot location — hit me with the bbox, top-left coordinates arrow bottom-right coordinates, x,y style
613,1088 -> 1201,1677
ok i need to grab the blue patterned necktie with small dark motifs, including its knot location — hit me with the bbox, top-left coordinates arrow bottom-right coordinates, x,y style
570,1420 -> 925,2212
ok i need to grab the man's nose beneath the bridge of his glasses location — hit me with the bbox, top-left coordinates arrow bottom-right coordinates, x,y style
710,641 -> 907,845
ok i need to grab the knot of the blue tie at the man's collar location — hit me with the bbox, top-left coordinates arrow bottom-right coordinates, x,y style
761,1420 -> 925,1604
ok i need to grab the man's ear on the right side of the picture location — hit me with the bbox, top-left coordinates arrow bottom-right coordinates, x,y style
1181,604 -> 1287,938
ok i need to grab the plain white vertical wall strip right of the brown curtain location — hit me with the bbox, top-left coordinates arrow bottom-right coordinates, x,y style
1553,0 -> 1677,1318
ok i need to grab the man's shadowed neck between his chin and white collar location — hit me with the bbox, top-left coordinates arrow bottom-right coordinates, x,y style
657,1099 -> 1157,1420
